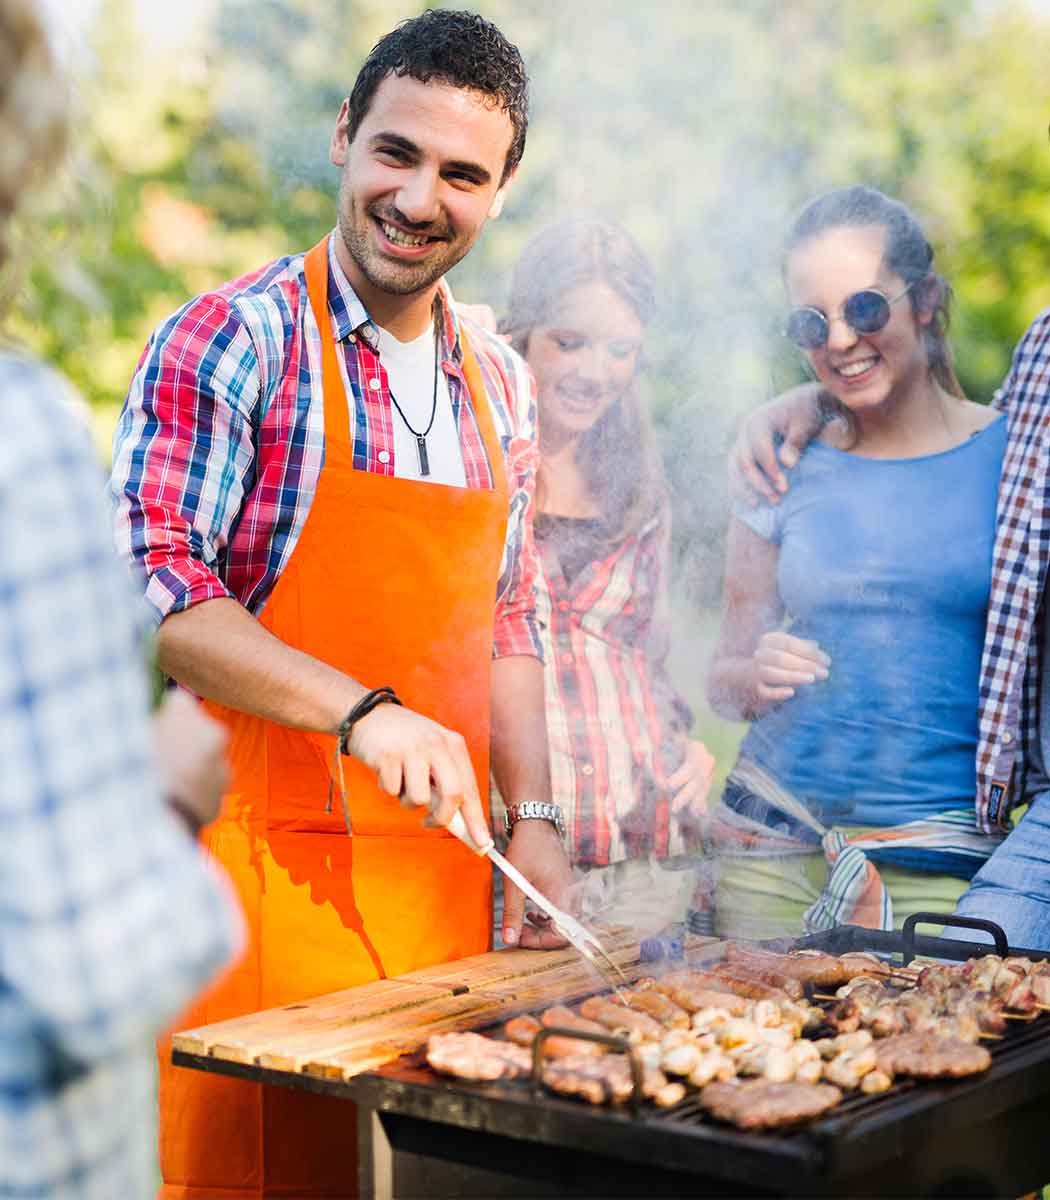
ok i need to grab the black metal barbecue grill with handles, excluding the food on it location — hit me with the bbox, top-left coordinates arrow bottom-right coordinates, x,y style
174,914 -> 1050,1198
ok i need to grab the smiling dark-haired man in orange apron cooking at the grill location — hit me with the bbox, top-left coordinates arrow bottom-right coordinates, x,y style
112,11 -> 569,1198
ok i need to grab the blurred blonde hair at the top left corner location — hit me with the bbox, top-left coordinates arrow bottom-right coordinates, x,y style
0,0 -> 70,269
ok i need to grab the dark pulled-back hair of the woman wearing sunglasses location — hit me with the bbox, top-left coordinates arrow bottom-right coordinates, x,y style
782,186 -> 965,398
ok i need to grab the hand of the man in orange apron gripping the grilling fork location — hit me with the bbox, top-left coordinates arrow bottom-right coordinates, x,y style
349,704 -> 491,846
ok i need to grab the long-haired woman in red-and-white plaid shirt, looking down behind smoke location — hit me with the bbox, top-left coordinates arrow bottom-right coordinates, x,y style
492,220 -> 714,935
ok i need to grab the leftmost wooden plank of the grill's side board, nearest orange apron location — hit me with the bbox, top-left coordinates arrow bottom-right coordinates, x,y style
172,979 -> 451,1063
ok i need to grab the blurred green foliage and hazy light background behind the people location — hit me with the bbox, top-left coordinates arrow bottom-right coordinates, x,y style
8,0 -> 1050,768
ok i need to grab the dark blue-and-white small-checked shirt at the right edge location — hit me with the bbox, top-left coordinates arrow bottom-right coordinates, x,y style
977,310 -> 1050,833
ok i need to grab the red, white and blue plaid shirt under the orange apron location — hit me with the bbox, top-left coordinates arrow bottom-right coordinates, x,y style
110,234 -> 540,656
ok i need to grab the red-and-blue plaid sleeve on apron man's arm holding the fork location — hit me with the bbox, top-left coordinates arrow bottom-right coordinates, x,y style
110,294 -> 259,623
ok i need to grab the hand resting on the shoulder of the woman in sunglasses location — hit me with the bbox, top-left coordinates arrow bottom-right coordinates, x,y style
730,383 -> 823,505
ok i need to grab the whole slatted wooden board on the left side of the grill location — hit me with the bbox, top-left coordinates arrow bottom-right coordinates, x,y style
172,932 -> 714,1079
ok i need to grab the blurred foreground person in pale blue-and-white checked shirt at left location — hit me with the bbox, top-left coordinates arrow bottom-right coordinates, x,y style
0,0 -> 238,1200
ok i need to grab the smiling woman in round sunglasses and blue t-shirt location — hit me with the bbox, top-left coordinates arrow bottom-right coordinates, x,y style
709,187 -> 1006,937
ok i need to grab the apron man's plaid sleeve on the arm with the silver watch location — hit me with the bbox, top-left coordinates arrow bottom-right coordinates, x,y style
492,353 -> 544,660
